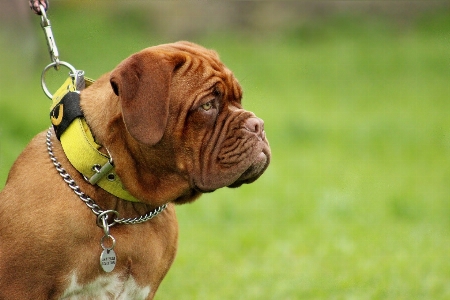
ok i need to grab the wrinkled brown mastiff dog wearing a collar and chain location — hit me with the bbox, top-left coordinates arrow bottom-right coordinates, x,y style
0,42 -> 270,299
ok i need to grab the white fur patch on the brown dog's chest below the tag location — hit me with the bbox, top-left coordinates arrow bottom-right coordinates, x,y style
61,274 -> 150,300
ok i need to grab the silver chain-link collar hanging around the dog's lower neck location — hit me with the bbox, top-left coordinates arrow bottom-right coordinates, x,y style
46,128 -> 167,226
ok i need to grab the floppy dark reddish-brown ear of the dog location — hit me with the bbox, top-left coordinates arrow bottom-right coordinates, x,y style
110,50 -> 184,145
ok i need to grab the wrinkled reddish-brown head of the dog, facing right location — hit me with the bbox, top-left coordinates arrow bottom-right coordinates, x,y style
105,42 -> 270,203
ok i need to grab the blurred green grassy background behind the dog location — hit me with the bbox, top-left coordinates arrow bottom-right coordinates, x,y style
0,0 -> 450,299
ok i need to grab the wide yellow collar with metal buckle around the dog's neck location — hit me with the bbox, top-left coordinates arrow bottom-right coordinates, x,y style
52,78 -> 139,202
